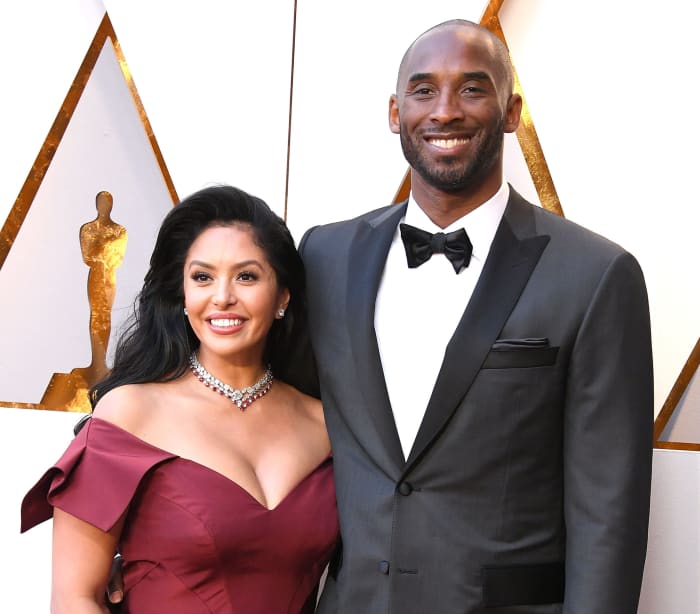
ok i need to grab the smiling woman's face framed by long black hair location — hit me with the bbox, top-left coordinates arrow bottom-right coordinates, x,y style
183,224 -> 289,366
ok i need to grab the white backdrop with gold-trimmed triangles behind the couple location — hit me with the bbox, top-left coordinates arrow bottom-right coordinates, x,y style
0,0 -> 700,614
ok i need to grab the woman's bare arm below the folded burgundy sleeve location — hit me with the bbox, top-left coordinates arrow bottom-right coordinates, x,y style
51,508 -> 124,614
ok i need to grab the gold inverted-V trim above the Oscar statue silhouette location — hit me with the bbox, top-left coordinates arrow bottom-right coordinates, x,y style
0,12 -> 178,268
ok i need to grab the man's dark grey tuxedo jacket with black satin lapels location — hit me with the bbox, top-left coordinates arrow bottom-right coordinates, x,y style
300,188 -> 653,614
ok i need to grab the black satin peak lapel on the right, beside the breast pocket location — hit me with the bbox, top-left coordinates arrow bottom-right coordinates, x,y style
404,195 -> 549,474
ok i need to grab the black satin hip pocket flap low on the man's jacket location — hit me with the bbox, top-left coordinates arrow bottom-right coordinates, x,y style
481,561 -> 564,608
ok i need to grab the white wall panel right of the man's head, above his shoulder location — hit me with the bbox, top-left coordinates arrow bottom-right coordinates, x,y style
501,0 -> 700,412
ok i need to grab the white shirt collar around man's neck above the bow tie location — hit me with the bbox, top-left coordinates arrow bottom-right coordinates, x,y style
404,182 -> 510,262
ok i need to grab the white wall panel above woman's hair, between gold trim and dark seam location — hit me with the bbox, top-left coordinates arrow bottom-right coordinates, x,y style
105,0 -> 294,214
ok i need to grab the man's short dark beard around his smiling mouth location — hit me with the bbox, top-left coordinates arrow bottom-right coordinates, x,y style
400,118 -> 504,192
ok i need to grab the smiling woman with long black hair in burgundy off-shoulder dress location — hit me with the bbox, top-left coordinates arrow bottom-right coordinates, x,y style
22,186 -> 338,614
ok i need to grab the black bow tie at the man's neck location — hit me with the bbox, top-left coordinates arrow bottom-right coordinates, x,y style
399,224 -> 472,273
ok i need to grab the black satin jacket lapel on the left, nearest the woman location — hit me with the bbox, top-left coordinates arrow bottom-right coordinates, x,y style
345,204 -> 406,477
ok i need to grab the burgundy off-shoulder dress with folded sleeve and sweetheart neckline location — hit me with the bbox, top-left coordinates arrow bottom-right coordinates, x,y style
22,418 -> 338,614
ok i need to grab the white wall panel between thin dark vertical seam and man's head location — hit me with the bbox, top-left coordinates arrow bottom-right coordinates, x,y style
288,0 -> 488,238
